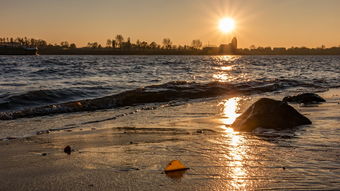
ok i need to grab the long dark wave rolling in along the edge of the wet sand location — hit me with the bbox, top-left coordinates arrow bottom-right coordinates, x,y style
0,79 -> 322,120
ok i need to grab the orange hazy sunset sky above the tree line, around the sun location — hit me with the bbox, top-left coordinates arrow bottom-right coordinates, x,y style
0,0 -> 340,48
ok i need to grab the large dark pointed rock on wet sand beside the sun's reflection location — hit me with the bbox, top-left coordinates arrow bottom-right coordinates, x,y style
231,98 -> 312,131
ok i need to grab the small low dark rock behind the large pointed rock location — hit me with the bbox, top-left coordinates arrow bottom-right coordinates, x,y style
282,93 -> 326,104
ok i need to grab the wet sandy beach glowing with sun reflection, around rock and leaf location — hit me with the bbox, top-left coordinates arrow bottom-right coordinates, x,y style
0,90 -> 340,190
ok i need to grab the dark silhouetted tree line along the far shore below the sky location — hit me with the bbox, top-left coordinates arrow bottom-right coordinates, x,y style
0,35 -> 340,55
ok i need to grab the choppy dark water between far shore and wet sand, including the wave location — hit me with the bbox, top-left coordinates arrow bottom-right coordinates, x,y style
0,56 -> 340,119
